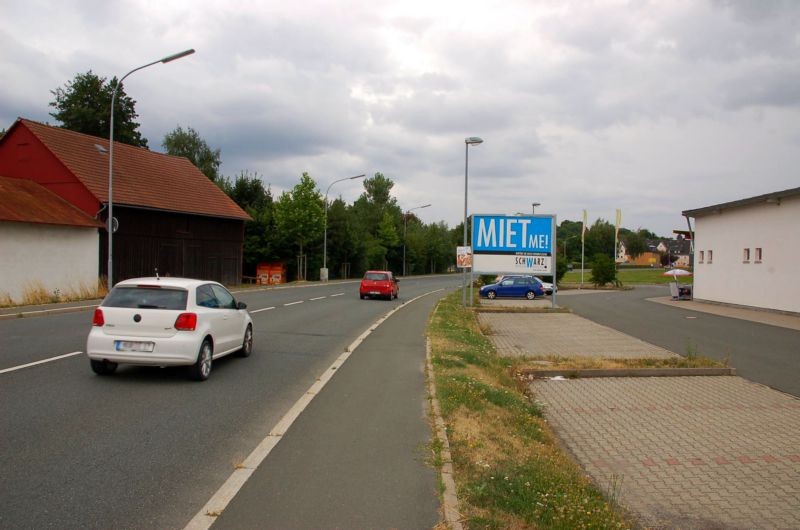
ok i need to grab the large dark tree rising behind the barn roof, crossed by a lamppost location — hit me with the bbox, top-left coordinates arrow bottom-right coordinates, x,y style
50,70 -> 147,148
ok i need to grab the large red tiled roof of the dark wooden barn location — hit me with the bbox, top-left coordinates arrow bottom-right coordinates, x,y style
20,119 -> 250,220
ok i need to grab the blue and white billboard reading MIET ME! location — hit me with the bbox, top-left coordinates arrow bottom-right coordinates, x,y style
472,215 -> 555,275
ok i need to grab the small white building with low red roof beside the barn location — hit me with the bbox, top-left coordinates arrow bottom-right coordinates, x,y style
0,177 -> 102,304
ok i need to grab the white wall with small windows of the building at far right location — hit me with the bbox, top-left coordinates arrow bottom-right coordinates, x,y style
694,197 -> 800,313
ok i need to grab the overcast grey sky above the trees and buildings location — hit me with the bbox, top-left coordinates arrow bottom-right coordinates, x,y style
0,0 -> 800,235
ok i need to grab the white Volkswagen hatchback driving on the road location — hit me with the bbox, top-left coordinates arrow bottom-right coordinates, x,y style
86,277 -> 253,381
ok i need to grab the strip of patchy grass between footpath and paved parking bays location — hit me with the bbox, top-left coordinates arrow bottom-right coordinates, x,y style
428,292 -> 630,529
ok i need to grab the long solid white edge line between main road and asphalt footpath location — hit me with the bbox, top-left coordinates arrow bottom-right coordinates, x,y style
184,289 -> 444,530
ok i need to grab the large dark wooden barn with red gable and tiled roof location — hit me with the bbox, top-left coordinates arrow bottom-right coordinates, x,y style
0,119 -> 250,285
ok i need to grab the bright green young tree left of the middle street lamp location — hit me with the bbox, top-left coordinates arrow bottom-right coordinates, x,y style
275,173 -> 325,279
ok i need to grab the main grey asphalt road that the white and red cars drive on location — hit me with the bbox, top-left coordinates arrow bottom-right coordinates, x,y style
0,276 -> 460,528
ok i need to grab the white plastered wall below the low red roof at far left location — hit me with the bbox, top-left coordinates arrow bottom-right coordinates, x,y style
0,221 -> 99,303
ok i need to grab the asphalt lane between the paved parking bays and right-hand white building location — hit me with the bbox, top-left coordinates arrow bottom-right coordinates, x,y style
558,285 -> 800,396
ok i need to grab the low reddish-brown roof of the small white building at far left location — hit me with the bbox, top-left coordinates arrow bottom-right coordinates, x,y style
0,177 -> 103,228
